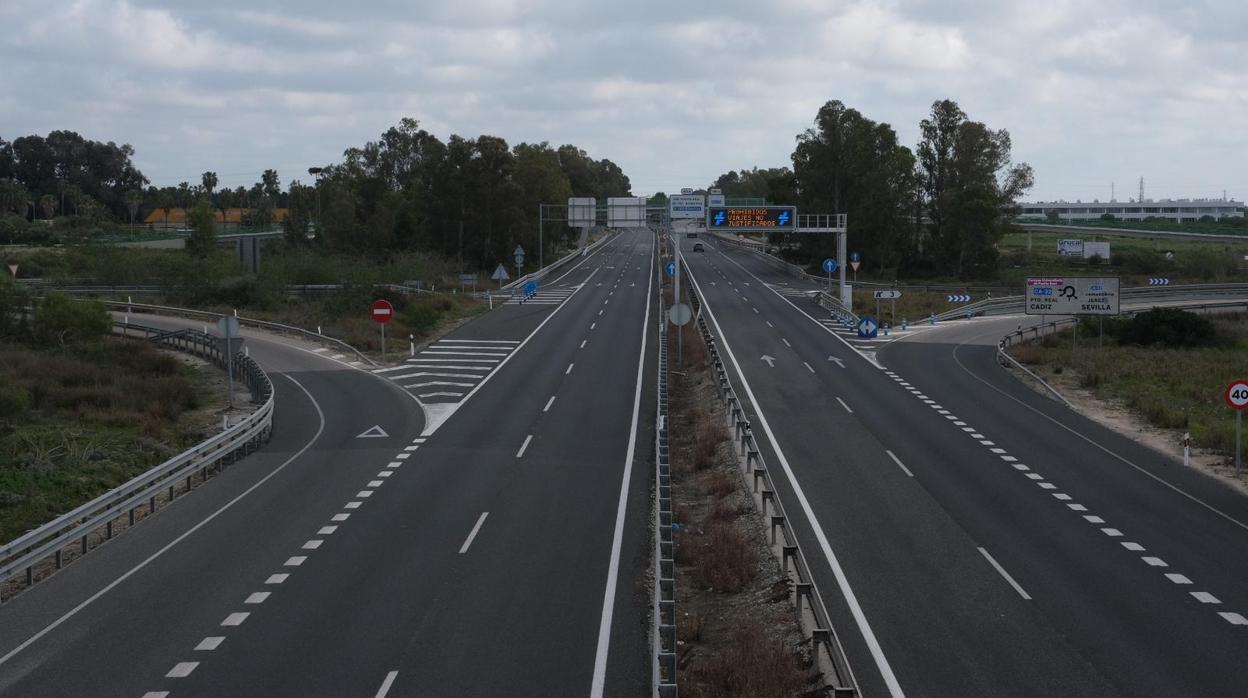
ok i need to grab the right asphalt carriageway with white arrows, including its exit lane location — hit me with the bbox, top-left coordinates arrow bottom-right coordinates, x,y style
680,231 -> 1248,697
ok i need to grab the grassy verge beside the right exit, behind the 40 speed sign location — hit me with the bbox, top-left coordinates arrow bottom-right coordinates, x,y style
1011,313 -> 1248,456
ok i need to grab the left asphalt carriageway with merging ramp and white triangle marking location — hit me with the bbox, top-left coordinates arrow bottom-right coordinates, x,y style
0,231 -> 656,698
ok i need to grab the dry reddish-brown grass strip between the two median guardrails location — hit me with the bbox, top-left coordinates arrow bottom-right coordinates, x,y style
668,280 -> 815,698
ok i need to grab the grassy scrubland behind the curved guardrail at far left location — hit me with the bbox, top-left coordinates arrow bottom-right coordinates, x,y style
0,338 -> 217,541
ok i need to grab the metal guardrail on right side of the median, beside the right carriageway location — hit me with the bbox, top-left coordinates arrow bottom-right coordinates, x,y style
686,260 -> 859,697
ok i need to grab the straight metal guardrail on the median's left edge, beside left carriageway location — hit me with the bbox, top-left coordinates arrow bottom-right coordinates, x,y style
651,308 -> 676,698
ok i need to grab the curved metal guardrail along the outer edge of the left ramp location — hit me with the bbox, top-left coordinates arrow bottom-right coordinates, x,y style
0,322 -> 273,602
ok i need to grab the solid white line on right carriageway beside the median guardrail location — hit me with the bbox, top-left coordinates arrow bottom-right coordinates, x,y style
685,258 -> 905,698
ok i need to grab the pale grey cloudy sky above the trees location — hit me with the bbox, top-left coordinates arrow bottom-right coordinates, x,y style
0,0 -> 1248,201
